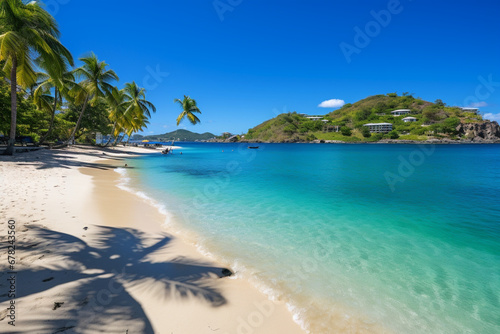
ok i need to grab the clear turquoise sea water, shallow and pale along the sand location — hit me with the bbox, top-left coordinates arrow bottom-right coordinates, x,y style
119,143 -> 500,333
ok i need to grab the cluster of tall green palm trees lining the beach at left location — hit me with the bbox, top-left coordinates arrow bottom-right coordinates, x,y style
0,0 -> 156,154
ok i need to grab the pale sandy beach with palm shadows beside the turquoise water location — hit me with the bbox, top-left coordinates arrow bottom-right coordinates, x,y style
0,148 -> 305,334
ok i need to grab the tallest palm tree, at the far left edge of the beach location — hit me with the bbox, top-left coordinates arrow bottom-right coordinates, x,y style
0,0 -> 73,155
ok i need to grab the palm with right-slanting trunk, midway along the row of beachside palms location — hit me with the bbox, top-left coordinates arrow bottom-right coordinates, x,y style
68,53 -> 119,143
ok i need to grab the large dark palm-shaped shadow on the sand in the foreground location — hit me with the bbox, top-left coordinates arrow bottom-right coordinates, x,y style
0,226 -> 228,333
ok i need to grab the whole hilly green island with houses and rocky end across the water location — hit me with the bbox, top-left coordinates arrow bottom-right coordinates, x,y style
232,93 -> 500,143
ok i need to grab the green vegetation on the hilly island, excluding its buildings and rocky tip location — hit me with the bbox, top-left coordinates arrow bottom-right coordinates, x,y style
244,93 -> 482,142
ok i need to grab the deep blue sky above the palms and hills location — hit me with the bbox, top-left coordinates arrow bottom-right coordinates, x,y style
49,0 -> 500,134
